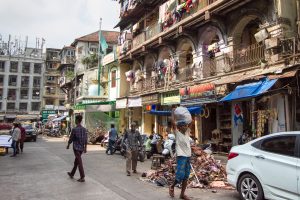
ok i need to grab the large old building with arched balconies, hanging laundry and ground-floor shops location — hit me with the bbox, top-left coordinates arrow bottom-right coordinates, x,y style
117,0 -> 300,151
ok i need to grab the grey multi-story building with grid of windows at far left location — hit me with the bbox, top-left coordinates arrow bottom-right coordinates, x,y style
0,45 -> 45,121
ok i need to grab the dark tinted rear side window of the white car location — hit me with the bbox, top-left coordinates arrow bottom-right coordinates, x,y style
261,136 -> 296,156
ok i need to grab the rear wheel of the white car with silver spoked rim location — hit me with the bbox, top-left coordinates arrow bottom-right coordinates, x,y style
237,174 -> 264,200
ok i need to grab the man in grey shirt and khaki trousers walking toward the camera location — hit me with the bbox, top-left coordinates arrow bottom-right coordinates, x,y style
123,122 -> 143,176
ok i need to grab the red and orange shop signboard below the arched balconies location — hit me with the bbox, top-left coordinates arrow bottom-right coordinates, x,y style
179,83 -> 217,105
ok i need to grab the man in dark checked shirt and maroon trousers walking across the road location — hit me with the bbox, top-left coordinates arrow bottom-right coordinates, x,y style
67,115 -> 87,182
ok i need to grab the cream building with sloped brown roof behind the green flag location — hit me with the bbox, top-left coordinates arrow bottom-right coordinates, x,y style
72,31 -> 119,129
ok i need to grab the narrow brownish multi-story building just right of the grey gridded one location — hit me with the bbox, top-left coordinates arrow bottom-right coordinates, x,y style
42,48 -> 65,111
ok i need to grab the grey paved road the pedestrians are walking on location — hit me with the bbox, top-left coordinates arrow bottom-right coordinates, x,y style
0,138 -> 238,200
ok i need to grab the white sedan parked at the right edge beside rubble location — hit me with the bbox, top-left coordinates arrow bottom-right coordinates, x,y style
226,132 -> 300,200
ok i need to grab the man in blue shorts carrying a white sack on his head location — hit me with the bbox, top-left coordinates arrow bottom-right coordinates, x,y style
169,107 -> 192,200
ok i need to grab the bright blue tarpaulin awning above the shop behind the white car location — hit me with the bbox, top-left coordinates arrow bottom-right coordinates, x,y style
220,79 -> 278,102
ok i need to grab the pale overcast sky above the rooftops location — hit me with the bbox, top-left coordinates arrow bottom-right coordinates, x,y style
0,0 -> 119,48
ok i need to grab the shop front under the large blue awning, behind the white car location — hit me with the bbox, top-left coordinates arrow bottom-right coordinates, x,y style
221,78 -> 287,150
